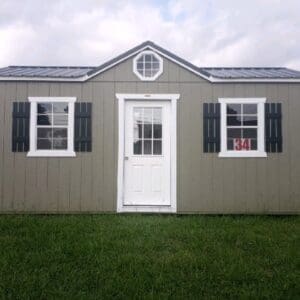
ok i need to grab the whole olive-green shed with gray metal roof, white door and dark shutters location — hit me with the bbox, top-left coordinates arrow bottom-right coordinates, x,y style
0,41 -> 300,214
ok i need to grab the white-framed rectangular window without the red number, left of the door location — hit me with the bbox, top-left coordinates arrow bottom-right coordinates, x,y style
28,97 -> 76,156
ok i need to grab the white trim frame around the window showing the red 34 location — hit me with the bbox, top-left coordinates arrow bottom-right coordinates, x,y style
219,98 -> 267,157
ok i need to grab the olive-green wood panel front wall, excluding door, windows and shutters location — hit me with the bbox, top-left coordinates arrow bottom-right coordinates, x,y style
0,59 -> 300,213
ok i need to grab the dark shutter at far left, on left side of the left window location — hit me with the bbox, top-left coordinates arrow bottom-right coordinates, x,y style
12,102 -> 30,152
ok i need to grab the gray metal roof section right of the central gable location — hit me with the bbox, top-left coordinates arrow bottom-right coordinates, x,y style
199,68 -> 300,79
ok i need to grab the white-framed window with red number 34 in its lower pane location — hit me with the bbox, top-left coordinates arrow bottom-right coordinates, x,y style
219,98 -> 266,157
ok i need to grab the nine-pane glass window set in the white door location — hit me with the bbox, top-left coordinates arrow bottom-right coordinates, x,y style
133,107 -> 162,155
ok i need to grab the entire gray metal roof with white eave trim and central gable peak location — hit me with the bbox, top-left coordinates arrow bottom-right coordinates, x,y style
0,41 -> 300,81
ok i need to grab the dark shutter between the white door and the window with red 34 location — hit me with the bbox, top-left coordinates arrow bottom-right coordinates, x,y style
203,103 -> 220,152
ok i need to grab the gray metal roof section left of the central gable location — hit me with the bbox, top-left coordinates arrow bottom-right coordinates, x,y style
0,66 -> 95,78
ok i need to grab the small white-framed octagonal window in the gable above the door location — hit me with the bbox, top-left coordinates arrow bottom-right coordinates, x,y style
133,51 -> 163,80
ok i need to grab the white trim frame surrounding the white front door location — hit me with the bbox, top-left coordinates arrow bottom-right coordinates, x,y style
116,94 -> 180,213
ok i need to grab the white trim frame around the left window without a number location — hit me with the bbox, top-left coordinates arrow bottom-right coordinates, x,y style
27,97 -> 76,157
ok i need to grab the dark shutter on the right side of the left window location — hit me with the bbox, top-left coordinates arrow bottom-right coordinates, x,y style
74,102 -> 92,152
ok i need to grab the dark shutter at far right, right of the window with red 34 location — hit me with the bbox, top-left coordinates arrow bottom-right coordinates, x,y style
265,103 -> 282,152
